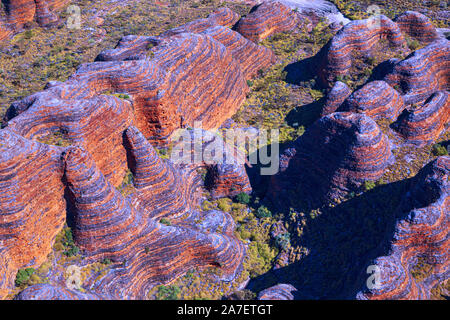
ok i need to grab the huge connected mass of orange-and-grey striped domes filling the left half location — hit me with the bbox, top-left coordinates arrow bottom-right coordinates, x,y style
0,6 -> 273,298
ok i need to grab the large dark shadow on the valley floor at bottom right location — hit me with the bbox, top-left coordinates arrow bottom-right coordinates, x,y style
247,179 -> 411,299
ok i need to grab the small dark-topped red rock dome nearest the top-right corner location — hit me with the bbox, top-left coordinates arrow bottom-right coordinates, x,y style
394,11 -> 439,43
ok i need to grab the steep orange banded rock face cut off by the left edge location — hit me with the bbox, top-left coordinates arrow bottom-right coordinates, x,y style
0,129 -> 65,293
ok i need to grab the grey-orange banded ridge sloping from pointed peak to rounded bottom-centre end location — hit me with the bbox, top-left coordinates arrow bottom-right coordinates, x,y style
64,148 -> 244,299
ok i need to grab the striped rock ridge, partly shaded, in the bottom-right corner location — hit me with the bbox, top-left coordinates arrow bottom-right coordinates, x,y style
357,156 -> 450,300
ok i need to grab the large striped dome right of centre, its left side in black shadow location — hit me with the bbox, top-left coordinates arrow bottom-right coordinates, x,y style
269,112 -> 391,206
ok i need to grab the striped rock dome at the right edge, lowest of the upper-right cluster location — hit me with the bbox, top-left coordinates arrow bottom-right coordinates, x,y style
394,91 -> 450,145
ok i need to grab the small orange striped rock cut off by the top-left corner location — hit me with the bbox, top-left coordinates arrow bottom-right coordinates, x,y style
0,0 -> 69,41
